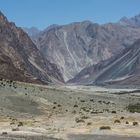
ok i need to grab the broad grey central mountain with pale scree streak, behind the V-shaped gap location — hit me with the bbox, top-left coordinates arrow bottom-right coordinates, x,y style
32,21 -> 140,81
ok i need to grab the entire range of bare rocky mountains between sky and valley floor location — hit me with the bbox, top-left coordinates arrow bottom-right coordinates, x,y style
0,10 -> 140,85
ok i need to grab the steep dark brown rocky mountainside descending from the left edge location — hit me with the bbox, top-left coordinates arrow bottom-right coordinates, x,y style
0,12 -> 63,83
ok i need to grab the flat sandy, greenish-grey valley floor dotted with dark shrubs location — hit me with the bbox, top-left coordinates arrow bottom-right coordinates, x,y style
0,80 -> 140,140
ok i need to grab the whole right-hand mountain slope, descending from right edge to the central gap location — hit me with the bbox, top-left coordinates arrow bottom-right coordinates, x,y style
69,39 -> 140,86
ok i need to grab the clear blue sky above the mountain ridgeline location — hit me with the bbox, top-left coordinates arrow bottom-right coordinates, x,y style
0,0 -> 140,29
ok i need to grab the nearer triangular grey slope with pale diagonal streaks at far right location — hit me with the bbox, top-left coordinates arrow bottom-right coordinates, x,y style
95,39 -> 140,85
